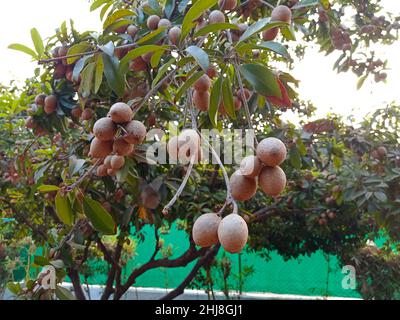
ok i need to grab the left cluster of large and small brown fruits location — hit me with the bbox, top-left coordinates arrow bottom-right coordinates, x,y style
89,102 -> 146,177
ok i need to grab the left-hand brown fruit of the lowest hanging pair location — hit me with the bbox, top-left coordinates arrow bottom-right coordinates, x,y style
192,213 -> 221,248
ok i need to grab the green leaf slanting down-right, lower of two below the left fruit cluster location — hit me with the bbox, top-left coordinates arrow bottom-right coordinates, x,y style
83,197 -> 117,235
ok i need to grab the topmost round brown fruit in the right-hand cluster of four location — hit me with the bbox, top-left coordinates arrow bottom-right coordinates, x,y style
257,137 -> 286,167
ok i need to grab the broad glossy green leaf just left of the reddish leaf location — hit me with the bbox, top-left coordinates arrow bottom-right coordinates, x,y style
240,63 -> 282,98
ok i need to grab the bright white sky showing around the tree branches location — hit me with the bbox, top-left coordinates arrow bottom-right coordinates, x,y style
0,0 -> 400,119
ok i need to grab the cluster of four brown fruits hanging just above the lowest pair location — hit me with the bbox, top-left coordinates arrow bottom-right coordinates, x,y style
230,137 -> 286,201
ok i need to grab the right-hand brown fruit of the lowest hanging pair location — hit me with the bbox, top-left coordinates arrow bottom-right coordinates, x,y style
218,213 -> 249,253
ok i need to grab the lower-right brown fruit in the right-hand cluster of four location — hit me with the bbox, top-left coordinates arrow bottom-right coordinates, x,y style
258,166 -> 286,197
